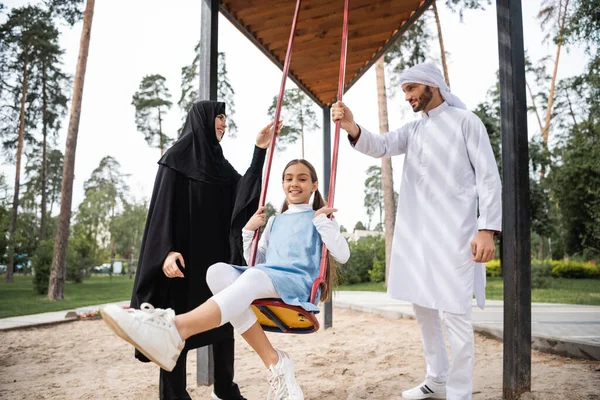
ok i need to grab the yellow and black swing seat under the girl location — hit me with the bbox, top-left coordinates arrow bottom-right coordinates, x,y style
252,278 -> 326,333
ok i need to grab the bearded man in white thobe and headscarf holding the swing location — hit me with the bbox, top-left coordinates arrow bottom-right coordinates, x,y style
332,63 -> 502,400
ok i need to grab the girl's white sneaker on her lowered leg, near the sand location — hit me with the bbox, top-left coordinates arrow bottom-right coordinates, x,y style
267,350 -> 304,400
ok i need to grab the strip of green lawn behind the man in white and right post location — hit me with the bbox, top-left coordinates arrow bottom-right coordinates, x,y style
337,277 -> 600,306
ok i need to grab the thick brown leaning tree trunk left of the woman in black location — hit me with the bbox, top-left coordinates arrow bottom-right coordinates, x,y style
48,0 -> 95,300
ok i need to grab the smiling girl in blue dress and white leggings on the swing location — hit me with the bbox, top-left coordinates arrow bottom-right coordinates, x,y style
103,160 -> 350,400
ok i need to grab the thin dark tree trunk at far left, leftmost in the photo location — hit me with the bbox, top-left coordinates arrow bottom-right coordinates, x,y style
6,53 -> 28,283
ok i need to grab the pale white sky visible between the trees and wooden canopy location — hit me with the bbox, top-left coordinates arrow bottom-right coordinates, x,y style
2,0 -> 586,231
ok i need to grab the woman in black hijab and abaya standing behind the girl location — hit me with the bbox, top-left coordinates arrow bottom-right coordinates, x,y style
131,101 -> 272,400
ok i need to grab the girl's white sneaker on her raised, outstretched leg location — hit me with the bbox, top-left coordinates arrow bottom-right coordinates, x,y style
102,303 -> 185,371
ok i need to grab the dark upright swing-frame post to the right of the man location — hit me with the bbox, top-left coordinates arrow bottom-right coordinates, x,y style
496,0 -> 531,400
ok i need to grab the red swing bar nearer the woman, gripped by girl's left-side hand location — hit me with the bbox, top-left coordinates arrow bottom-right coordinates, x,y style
248,0 -> 302,266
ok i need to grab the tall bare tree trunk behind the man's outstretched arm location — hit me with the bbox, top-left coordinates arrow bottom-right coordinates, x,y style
375,57 -> 396,286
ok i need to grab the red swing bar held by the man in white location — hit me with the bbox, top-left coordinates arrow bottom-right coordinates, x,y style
310,0 -> 349,304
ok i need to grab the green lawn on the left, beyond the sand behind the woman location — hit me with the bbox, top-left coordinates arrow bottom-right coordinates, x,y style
0,275 -> 133,318
